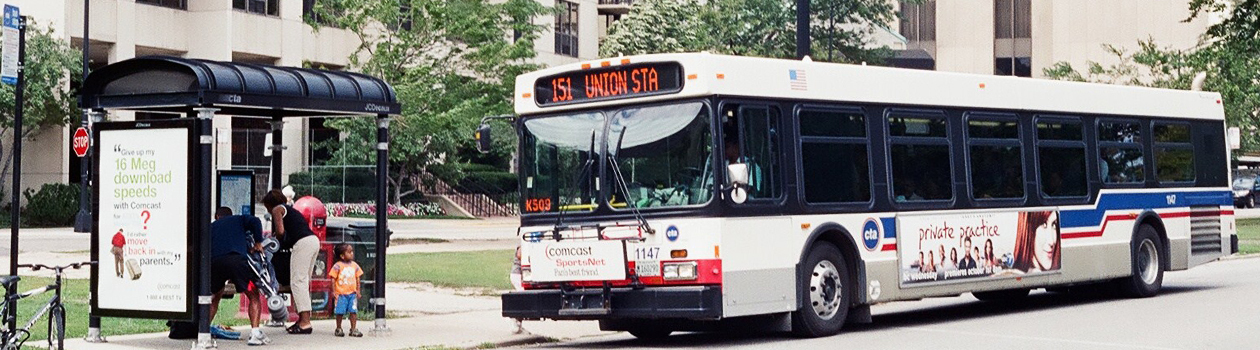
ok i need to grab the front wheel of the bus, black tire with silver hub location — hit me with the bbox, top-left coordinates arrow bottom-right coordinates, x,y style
791,242 -> 856,337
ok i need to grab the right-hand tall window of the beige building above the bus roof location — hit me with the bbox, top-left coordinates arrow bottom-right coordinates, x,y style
993,0 -> 1032,77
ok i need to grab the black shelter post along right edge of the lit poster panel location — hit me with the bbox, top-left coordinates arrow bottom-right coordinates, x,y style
193,107 -> 219,349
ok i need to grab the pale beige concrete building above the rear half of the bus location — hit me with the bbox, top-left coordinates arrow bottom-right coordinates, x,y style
896,0 -> 1213,77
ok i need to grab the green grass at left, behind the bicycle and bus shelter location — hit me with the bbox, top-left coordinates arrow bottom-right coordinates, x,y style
18,276 -> 249,346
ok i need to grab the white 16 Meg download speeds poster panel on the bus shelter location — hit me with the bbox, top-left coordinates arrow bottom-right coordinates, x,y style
92,122 -> 195,319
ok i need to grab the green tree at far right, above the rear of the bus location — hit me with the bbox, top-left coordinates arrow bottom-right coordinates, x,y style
1043,0 -> 1260,150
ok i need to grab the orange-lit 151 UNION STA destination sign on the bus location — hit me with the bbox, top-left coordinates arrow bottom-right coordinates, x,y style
534,62 -> 683,106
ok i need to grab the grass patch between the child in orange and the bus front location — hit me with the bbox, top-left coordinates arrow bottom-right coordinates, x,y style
386,251 -> 515,290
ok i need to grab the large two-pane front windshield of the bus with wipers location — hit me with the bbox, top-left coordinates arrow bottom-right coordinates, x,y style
520,102 -> 714,214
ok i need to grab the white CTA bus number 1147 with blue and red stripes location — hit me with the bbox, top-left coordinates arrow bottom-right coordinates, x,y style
488,53 -> 1237,337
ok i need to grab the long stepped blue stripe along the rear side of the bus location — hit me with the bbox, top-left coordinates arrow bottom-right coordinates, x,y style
1058,191 -> 1234,228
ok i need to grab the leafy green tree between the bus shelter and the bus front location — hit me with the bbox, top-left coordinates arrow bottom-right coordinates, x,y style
307,0 -> 547,204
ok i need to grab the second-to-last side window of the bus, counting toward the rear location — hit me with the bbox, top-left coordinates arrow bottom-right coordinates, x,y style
1099,121 -> 1147,184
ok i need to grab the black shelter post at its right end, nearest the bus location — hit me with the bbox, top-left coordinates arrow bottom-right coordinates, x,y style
372,115 -> 389,336
